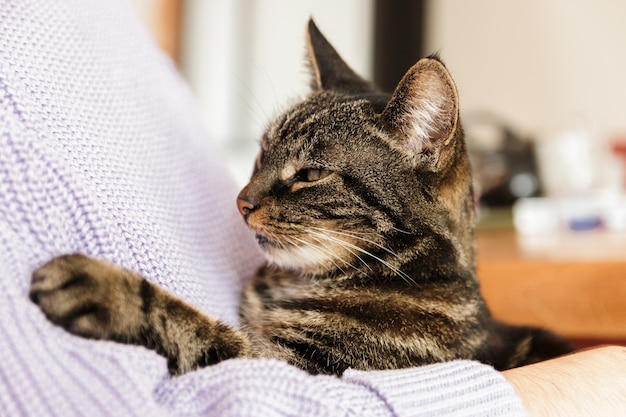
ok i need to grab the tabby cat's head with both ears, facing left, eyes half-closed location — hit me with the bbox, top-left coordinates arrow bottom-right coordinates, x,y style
237,21 -> 474,275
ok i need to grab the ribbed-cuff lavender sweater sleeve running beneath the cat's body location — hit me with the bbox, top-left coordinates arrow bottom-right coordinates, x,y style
152,360 -> 527,417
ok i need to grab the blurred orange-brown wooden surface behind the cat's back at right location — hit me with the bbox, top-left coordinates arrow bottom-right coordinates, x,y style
478,230 -> 626,342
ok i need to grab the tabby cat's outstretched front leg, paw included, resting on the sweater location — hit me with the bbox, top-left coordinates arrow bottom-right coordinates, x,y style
30,254 -> 251,374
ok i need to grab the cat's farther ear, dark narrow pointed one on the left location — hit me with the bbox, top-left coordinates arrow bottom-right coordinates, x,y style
307,19 -> 376,94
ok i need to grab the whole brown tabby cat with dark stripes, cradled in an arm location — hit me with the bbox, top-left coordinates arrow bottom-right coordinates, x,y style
30,21 -> 571,375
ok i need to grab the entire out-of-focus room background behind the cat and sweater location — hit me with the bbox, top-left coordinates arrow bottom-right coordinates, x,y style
130,0 -> 626,346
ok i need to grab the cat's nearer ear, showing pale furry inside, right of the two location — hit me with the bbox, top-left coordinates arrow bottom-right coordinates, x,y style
380,56 -> 459,164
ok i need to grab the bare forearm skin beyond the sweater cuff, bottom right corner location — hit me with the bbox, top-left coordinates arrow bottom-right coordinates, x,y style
503,346 -> 626,417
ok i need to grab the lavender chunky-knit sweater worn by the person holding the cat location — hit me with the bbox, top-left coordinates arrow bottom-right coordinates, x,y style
0,0 -> 525,417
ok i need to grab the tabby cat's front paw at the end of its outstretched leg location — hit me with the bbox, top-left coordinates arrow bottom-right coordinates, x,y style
29,254 -> 142,339
